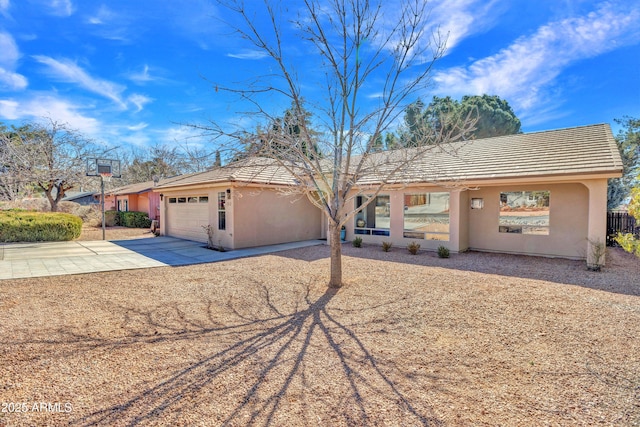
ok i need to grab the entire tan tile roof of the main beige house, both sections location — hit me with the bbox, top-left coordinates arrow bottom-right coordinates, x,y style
156,124 -> 622,188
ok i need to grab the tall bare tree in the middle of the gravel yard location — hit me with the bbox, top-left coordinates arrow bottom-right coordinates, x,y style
200,0 -> 473,287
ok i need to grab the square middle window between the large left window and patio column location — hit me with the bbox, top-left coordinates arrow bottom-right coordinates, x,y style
404,192 -> 449,241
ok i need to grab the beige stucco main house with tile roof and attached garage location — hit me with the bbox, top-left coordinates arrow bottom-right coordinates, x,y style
154,124 -> 622,259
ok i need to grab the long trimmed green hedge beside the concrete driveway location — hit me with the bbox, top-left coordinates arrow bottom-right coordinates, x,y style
0,211 -> 82,242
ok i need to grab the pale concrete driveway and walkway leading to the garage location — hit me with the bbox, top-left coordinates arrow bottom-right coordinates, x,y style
0,236 -> 324,280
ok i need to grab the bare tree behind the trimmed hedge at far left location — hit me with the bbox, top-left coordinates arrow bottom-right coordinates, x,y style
0,120 -> 95,212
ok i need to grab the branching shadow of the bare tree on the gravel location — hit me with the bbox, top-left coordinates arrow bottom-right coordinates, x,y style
66,284 -> 442,426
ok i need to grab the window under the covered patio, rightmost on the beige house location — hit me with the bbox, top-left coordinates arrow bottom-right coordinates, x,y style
498,191 -> 550,235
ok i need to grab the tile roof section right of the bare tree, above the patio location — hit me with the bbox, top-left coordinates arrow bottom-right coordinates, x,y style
358,124 -> 622,184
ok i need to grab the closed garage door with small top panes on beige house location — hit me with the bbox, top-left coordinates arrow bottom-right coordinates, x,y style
167,196 -> 210,243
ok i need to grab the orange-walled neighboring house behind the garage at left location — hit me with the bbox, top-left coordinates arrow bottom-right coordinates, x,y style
104,175 -> 190,220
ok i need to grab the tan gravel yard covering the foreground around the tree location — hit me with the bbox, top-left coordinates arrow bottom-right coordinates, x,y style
0,245 -> 640,426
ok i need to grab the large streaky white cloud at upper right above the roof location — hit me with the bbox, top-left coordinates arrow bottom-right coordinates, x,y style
434,3 -> 640,113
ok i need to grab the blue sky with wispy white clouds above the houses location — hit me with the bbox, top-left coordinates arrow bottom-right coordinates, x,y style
0,0 -> 640,152
